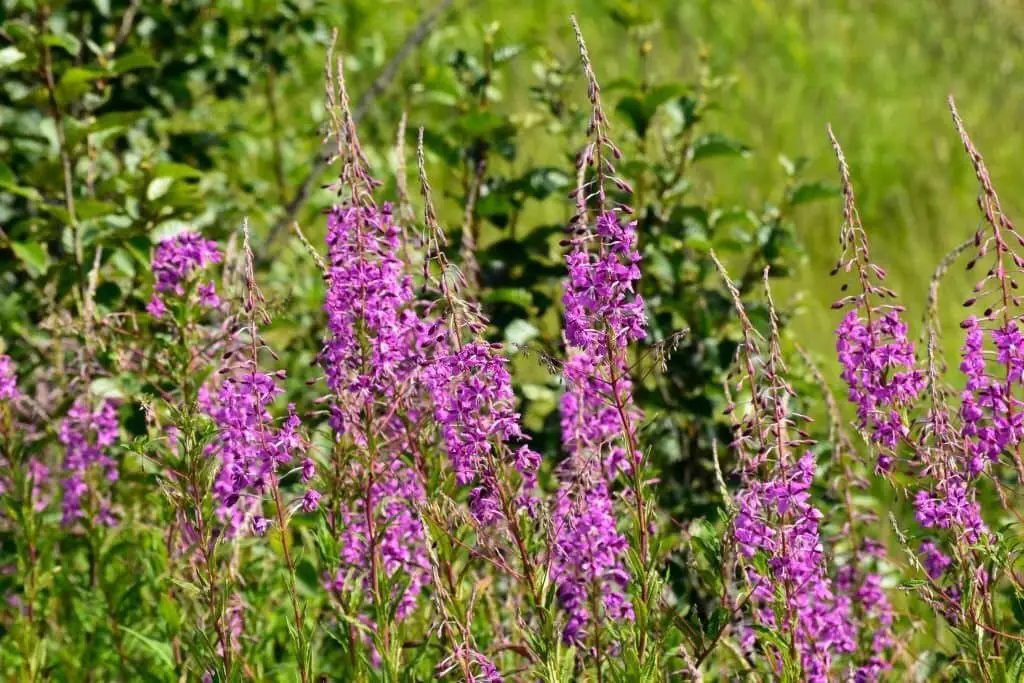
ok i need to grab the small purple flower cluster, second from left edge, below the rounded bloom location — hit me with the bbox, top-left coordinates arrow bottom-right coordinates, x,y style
57,397 -> 119,526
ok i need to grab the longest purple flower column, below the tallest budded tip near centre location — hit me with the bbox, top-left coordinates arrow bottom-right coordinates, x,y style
551,211 -> 646,643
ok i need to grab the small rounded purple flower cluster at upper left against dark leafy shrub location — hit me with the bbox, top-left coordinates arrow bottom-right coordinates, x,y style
146,231 -> 221,317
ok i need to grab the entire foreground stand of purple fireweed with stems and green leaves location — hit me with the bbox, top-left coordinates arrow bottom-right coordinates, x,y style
9,14 -> 1024,683
